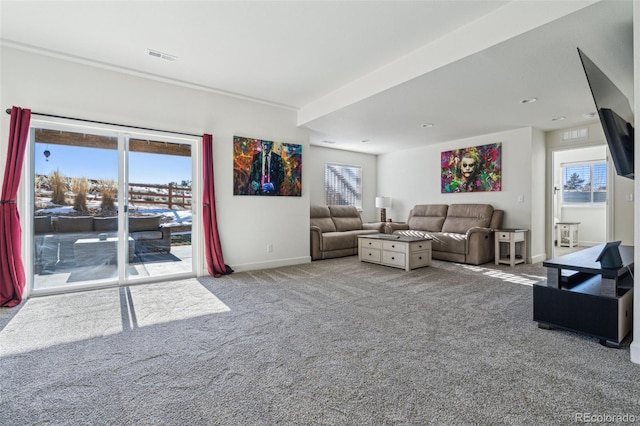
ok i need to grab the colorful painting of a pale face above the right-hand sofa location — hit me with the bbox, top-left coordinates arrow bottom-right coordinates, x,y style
440,142 -> 502,193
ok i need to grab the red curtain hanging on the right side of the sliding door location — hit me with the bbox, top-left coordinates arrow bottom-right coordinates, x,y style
202,134 -> 233,278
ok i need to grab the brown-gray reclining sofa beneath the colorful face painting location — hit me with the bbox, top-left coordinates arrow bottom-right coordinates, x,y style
386,204 -> 504,265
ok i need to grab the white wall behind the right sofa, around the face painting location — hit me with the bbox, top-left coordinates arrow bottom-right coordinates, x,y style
378,127 -> 545,261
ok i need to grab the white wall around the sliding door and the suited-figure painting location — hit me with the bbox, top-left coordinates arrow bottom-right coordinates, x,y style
0,47 -> 310,271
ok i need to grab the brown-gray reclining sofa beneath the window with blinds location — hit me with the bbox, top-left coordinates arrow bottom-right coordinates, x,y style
310,205 -> 385,260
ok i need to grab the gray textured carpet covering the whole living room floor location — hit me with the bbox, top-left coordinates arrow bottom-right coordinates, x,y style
0,256 -> 640,425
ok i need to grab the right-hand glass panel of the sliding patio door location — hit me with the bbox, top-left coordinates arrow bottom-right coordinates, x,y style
127,137 -> 193,280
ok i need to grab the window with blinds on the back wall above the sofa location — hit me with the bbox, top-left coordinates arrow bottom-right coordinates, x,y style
324,164 -> 362,210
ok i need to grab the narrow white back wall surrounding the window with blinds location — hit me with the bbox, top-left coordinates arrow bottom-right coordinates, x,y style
303,145 -> 382,222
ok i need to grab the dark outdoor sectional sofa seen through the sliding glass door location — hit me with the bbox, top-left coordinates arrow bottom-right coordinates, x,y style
33,216 -> 171,269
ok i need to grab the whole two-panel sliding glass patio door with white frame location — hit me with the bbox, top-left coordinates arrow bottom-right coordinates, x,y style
25,120 -> 197,295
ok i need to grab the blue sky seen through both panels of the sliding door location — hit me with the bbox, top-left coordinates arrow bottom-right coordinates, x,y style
35,143 -> 192,185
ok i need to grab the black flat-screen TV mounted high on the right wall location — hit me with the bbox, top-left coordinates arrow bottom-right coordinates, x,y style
578,48 -> 634,179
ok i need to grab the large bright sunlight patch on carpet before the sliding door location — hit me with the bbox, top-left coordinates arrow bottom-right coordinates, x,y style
0,279 -> 230,357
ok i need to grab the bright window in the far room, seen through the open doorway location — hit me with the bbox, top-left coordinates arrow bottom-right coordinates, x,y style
562,160 -> 607,204
